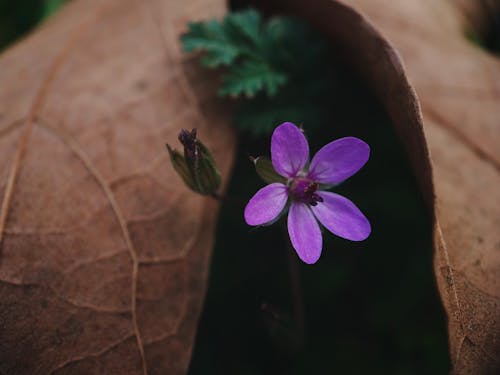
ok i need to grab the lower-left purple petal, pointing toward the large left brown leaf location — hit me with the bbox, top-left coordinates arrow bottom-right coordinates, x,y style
245,182 -> 288,225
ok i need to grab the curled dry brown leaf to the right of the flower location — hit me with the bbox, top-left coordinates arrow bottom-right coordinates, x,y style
275,0 -> 500,375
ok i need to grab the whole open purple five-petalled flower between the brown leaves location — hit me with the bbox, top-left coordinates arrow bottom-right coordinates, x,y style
245,122 -> 371,264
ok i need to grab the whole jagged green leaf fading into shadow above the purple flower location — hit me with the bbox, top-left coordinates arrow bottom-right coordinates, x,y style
182,9 -> 334,135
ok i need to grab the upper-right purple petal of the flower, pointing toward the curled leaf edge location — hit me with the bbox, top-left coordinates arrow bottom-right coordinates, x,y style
308,137 -> 370,185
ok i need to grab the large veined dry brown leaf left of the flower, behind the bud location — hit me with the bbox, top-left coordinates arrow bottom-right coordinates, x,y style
0,0 -> 235,375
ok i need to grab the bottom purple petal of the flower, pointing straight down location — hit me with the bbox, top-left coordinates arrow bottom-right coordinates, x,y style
288,202 -> 323,264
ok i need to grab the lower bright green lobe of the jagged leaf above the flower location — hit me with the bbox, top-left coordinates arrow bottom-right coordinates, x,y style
219,61 -> 287,98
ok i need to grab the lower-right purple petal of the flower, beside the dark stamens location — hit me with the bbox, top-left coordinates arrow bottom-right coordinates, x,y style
311,191 -> 371,241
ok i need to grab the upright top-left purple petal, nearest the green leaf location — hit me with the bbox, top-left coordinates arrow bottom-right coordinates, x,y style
271,122 -> 309,177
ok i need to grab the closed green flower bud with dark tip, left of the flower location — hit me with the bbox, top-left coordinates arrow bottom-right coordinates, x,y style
167,129 -> 221,195
